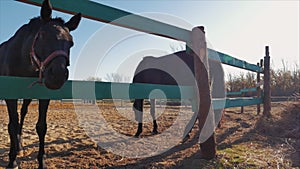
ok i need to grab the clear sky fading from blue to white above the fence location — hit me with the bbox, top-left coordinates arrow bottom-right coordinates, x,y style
0,0 -> 300,79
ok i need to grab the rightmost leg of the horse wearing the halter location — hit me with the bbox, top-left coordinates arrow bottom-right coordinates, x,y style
36,99 -> 50,168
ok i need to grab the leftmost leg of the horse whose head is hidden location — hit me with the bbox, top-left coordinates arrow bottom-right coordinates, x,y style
133,99 -> 144,137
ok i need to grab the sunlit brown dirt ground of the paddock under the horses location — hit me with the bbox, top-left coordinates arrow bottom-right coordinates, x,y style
0,101 -> 300,169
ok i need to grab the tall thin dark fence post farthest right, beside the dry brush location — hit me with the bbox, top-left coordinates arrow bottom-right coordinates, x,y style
263,46 -> 271,117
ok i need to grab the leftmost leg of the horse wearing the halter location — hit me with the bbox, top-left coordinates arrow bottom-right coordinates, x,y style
5,99 -> 19,168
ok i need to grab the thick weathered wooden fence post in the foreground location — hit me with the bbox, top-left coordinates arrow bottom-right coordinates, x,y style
191,26 -> 216,159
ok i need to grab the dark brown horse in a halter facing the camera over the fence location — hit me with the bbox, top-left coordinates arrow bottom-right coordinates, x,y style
0,0 -> 81,168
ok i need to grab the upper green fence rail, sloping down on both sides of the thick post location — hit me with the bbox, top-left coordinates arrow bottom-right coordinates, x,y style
17,0 -> 263,73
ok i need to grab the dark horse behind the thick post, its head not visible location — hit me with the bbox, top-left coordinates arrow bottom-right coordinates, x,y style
133,51 -> 225,137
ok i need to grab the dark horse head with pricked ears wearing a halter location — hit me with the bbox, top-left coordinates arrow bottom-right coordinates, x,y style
30,0 -> 81,89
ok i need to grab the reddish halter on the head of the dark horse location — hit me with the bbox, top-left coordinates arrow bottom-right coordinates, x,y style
30,31 -> 69,87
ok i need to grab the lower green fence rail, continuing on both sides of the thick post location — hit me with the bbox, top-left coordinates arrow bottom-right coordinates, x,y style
0,76 -> 262,109
